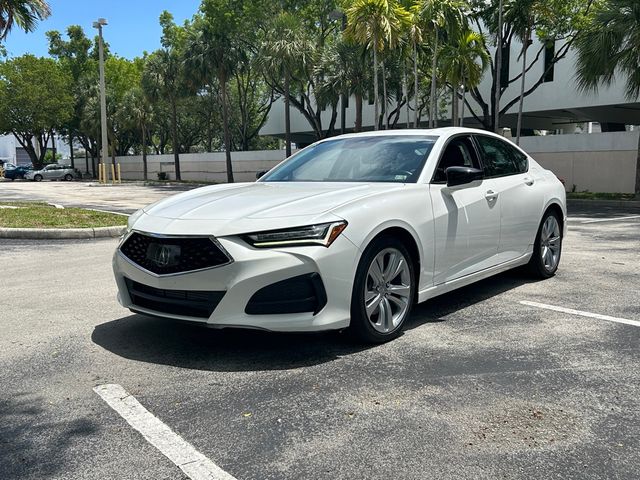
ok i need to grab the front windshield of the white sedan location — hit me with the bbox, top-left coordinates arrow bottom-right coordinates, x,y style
260,135 -> 436,183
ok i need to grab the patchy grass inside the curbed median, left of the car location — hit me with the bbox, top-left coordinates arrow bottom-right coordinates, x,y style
0,201 -> 127,228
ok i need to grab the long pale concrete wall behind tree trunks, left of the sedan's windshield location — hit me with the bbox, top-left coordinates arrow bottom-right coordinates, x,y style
116,150 -> 285,183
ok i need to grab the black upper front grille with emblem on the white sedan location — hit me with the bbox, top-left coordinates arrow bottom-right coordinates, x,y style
120,232 -> 231,275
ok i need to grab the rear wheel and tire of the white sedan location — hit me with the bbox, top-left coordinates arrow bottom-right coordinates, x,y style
528,210 -> 562,279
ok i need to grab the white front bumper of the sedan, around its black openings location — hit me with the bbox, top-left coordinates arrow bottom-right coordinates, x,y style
113,235 -> 359,332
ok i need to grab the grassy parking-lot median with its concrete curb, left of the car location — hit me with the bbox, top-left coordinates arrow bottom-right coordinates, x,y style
0,201 -> 127,239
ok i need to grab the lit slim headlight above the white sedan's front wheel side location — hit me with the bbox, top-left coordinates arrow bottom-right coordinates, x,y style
244,220 -> 347,248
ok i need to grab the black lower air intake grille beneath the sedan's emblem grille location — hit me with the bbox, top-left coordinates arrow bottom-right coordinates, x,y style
125,278 -> 225,318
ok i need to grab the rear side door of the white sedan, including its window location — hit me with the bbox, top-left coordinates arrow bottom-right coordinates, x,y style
475,135 -> 544,261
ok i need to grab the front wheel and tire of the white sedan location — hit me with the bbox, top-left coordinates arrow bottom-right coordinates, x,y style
349,235 -> 416,344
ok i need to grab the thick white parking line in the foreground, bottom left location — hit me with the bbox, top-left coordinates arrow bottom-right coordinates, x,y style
93,384 -> 235,480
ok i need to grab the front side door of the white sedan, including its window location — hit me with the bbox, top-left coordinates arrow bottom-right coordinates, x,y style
429,135 -> 500,285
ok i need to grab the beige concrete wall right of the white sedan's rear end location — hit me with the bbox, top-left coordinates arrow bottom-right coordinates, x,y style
520,131 -> 640,193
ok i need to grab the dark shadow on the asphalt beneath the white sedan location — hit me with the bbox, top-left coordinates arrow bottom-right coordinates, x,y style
91,271 -> 531,371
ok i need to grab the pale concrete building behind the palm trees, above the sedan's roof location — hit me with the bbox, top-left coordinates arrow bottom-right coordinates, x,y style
260,39 -> 640,145
